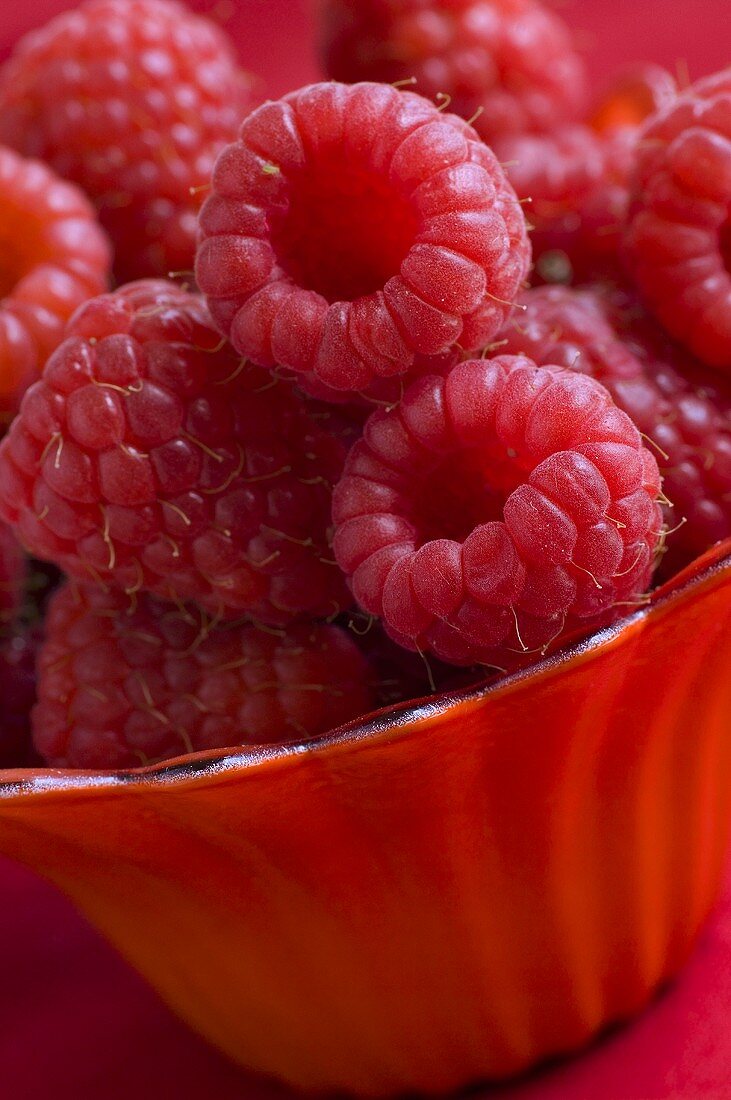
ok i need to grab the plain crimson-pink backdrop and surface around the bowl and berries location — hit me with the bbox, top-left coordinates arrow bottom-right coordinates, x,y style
0,0 -> 731,1100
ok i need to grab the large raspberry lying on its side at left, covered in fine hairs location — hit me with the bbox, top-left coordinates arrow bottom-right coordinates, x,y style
0,281 -> 346,624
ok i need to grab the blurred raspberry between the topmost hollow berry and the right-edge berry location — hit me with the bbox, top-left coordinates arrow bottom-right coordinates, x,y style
496,124 -> 633,283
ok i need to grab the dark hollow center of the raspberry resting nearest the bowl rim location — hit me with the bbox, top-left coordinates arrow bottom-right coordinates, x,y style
410,448 -> 525,545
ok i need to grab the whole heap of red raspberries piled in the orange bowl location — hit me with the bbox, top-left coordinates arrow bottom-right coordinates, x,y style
0,0 -> 731,769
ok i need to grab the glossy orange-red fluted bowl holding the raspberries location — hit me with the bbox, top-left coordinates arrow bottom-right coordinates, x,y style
0,543 -> 731,1097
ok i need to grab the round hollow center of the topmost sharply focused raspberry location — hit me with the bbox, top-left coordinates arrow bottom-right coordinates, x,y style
273,161 -> 417,303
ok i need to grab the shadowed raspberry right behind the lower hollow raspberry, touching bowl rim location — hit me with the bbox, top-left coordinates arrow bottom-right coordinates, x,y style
502,286 -> 731,575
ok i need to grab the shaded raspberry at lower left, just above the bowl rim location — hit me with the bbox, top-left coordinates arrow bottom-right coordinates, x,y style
33,585 -> 370,768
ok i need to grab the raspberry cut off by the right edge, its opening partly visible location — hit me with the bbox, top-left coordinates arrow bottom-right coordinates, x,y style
624,68 -> 731,372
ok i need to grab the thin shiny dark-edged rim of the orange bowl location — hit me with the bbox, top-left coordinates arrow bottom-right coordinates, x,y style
0,538 -> 731,800
